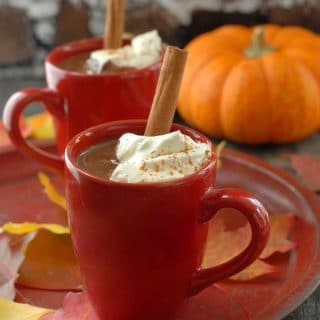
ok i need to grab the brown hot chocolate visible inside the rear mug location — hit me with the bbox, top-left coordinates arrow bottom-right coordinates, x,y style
58,52 -> 135,74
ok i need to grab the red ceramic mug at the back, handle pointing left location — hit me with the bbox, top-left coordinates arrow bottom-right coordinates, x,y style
3,38 -> 161,172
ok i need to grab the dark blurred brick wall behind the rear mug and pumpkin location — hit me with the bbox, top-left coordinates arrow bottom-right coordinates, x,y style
0,0 -> 320,112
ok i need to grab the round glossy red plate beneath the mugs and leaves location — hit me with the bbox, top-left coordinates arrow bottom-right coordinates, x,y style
0,144 -> 320,320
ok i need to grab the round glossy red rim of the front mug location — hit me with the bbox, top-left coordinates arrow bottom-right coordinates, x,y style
64,119 -> 217,188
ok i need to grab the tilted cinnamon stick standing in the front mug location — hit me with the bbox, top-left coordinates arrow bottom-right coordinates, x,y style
144,46 -> 187,136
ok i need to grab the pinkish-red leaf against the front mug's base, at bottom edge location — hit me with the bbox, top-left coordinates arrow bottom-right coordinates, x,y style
41,292 -> 99,320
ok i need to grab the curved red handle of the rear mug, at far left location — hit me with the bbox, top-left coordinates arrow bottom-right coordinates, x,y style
3,88 -> 65,175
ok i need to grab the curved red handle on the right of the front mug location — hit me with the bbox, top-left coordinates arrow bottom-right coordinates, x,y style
188,188 -> 270,296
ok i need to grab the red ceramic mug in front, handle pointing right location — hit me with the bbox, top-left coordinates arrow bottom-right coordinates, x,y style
65,120 -> 269,320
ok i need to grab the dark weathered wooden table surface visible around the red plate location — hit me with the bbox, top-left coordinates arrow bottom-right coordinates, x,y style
0,77 -> 320,320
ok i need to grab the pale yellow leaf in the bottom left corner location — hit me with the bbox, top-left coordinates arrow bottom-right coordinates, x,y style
0,298 -> 54,320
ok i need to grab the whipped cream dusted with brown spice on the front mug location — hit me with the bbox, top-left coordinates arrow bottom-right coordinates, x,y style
110,131 -> 211,182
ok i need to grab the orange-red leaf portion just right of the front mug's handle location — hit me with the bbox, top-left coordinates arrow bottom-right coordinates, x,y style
260,214 -> 296,259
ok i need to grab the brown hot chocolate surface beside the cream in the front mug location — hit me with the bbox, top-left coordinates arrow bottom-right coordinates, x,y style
77,140 -> 118,179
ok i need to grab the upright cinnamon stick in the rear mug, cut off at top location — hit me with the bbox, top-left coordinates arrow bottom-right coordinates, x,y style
103,0 -> 125,49
